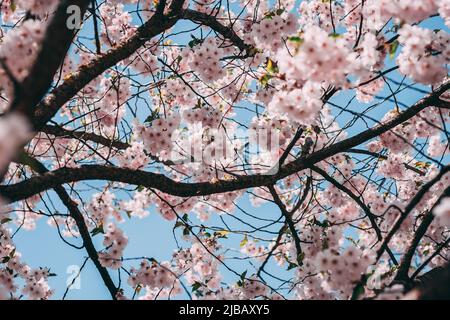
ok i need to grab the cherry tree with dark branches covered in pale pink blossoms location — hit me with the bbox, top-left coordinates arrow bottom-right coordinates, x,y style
0,0 -> 450,299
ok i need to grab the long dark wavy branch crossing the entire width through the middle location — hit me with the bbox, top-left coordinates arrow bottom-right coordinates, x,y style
0,80 -> 450,201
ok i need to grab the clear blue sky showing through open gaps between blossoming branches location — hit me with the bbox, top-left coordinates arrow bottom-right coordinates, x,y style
7,1 -> 450,299
